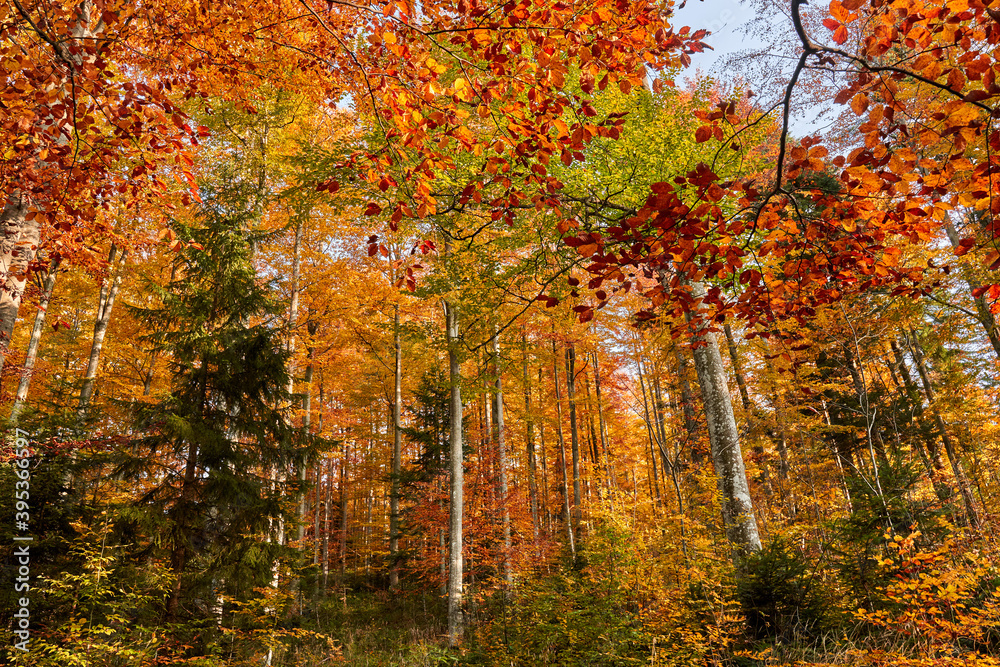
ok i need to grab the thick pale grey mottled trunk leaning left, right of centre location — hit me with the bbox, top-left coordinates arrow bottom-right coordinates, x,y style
691,282 -> 761,554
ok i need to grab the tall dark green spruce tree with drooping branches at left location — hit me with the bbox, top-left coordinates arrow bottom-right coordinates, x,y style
118,204 -> 292,620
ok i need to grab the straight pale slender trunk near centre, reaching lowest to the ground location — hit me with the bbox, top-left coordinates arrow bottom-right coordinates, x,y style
444,301 -> 465,646
